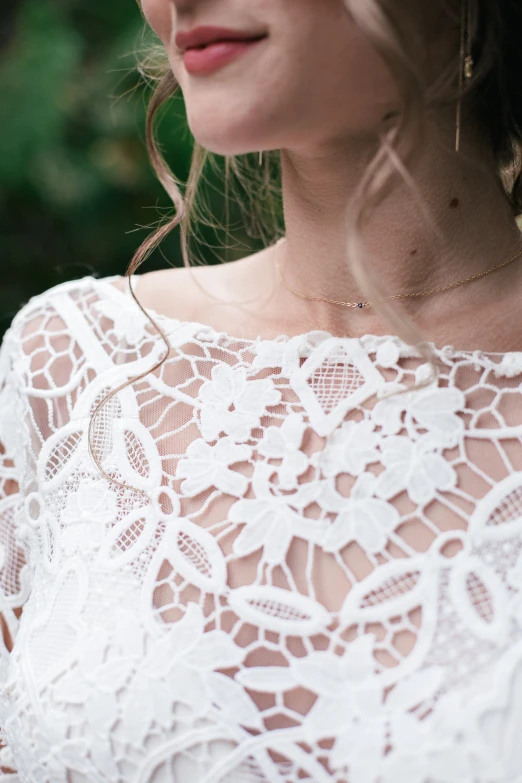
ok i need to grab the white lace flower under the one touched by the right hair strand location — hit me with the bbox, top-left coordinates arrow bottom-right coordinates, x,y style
376,436 -> 457,505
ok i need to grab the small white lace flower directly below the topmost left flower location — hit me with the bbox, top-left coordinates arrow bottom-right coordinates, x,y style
176,438 -> 252,497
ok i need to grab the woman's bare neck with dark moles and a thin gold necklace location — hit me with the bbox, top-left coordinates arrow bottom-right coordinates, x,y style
271,114 -> 522,344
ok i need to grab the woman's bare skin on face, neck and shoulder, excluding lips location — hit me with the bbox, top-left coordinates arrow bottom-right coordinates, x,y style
139,0 -> 522,351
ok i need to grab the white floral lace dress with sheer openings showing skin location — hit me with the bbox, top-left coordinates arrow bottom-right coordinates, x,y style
0,277 -> 522,783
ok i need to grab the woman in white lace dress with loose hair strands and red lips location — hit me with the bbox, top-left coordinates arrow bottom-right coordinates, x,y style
0,0 -> 522,783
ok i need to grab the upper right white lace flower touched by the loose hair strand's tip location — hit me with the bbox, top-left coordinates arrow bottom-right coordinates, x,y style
372,384 -> 466,446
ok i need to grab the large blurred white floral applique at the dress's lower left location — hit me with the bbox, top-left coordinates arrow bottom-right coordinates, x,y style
53,603 -> 246,752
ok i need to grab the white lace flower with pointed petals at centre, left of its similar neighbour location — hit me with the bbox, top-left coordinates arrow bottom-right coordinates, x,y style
228,463 -> 301,565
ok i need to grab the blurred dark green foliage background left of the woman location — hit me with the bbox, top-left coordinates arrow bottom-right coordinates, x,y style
0,0 -> 280,335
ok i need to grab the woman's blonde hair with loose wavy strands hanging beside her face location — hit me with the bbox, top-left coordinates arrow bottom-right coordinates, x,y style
89,0 -> 522,486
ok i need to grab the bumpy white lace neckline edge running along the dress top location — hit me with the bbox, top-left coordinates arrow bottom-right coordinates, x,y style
97,275 -> 522,362
